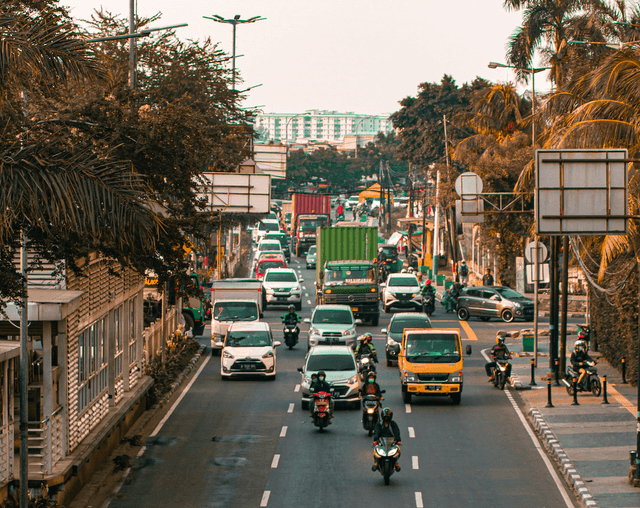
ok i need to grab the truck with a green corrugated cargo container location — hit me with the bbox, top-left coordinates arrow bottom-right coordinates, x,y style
316,226 -> 380,326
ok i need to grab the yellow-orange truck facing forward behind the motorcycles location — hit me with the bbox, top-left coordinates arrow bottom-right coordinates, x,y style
398,328 -> 471,404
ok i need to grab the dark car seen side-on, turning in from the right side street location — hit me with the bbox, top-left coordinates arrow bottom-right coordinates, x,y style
457,286 -> 534,323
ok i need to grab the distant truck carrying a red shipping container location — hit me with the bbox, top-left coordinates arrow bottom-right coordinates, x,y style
291,193 -> 331,256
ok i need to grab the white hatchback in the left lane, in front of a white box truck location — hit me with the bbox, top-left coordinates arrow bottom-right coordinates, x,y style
220,321 -> 280,380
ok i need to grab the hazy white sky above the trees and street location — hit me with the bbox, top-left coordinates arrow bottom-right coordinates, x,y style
61,0 -> 547,114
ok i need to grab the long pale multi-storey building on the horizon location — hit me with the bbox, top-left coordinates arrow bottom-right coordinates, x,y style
255,109 -> 393,148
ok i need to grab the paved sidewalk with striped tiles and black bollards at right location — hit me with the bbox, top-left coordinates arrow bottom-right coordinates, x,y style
506,338 -> 640,508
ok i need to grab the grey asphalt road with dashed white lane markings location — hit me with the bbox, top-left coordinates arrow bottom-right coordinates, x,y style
111,252 -> 573,508
